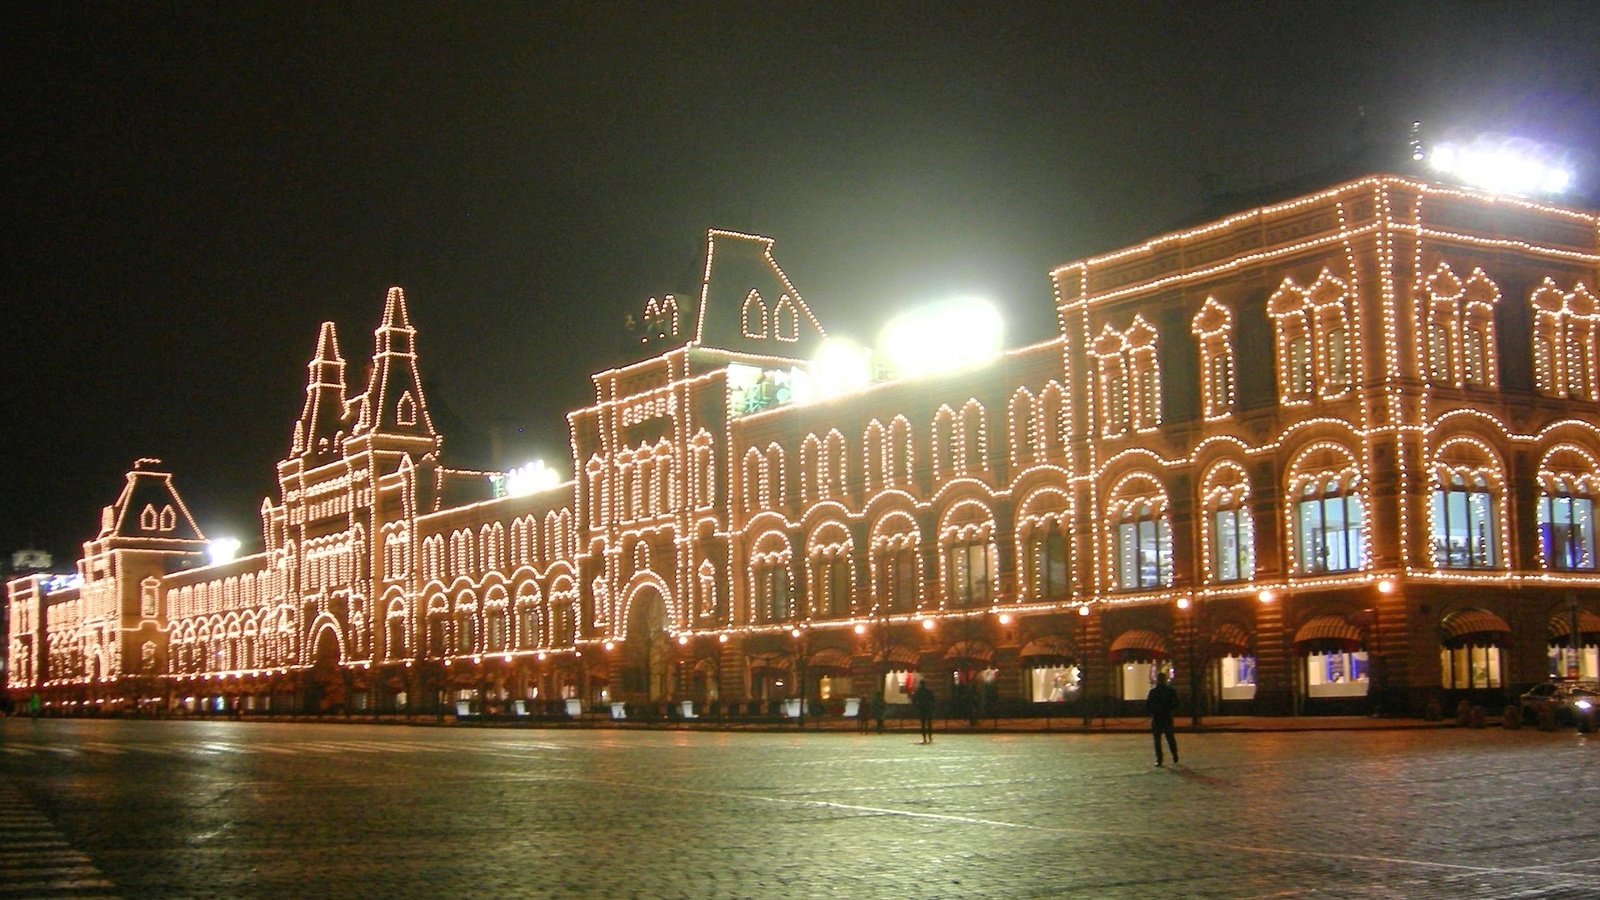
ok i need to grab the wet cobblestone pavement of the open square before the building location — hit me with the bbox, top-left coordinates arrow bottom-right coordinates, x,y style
0,719 -> 1600,898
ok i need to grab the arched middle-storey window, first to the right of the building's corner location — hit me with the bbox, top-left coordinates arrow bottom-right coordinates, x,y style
1429,436 -> 1509,569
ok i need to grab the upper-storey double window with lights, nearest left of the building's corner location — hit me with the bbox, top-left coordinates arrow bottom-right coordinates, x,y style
1267,269 -> 1355,407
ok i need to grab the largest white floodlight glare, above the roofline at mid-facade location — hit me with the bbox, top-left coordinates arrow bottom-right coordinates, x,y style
878,299 -> 1005,378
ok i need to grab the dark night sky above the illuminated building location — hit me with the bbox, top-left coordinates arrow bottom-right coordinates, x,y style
0,2 -> 1600,562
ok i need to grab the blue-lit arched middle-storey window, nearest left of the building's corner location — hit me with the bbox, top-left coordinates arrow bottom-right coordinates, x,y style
1288,442 -> 1366,575
